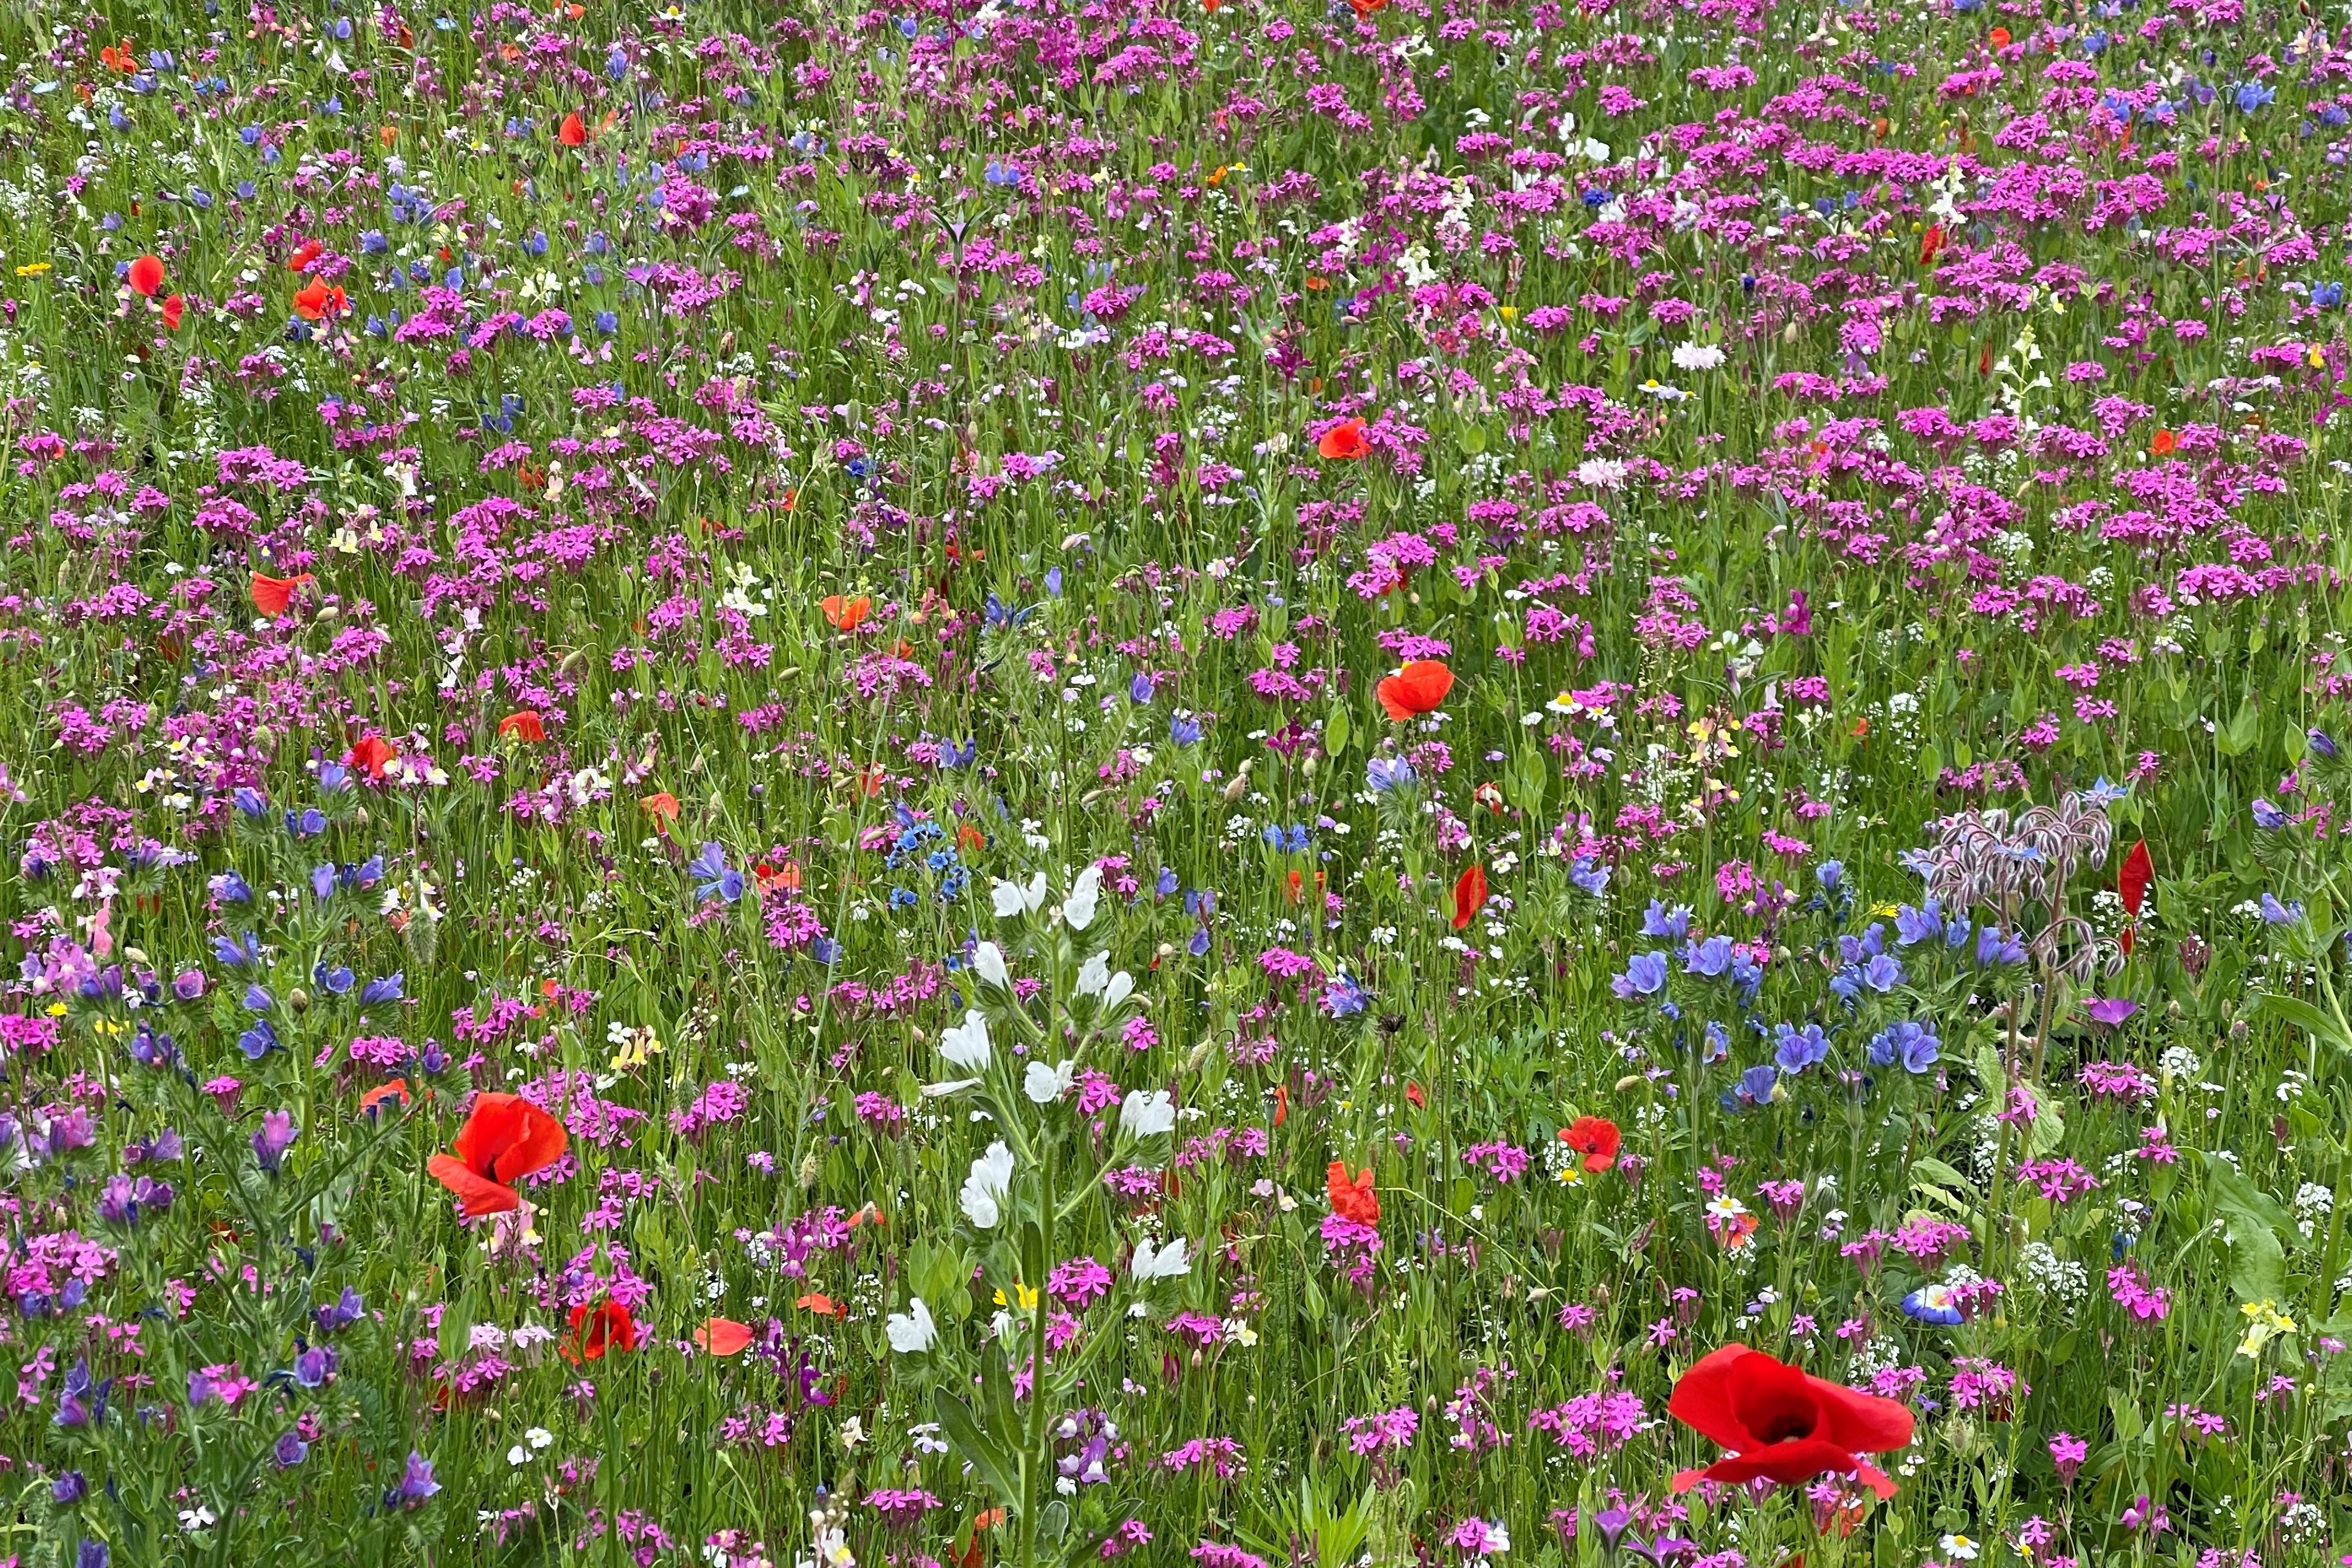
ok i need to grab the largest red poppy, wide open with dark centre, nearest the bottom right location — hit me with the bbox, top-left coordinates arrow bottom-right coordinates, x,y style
1665,1345 -> 1912,1497
